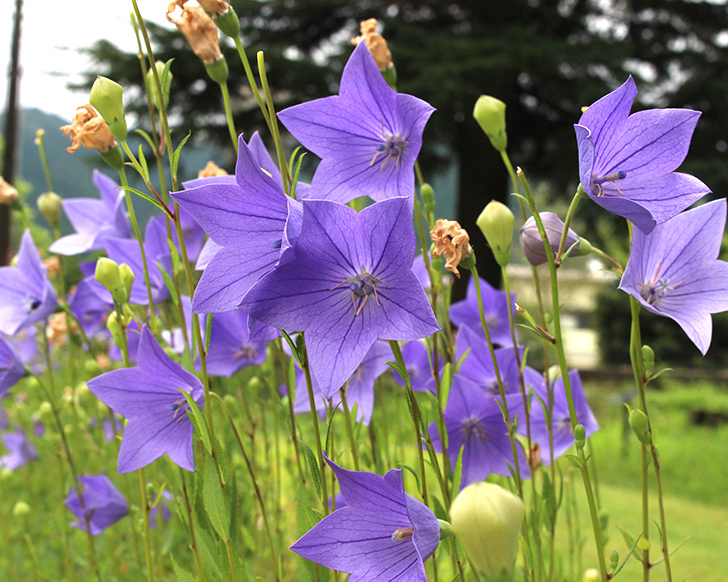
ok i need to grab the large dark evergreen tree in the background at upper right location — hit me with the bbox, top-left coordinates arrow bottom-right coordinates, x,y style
78,0 -> 728,290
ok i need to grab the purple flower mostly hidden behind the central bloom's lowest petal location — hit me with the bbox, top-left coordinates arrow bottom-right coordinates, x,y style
293,342 -> 393,426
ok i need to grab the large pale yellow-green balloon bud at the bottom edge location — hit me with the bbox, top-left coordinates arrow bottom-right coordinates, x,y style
450,481 -> 526,578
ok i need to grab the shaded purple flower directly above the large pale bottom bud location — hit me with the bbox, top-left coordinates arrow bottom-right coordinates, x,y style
430,374 -> 530,489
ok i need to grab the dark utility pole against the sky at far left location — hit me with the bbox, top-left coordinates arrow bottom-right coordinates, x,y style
0,0 -> 23,266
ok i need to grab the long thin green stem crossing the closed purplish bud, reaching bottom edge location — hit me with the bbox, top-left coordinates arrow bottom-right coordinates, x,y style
517,168 -> 608,582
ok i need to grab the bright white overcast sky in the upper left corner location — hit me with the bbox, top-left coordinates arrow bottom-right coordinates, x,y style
0,0 -> 166,122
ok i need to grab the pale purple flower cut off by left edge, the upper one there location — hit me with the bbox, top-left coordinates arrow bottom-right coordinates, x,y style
0,230 -> 58,335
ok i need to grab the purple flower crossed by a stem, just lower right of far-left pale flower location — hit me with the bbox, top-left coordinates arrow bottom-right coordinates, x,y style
106,220 -> 172,305
